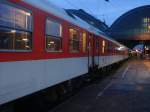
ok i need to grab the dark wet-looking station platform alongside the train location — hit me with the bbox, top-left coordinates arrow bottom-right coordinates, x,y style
49,60 -> 150,112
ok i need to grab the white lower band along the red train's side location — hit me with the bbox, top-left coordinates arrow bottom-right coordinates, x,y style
0,56 -> 125,104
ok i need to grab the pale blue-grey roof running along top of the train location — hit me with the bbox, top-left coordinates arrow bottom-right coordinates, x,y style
23,0 -> 125,47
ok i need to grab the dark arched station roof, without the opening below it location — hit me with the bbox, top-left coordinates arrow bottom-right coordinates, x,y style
108,5 -> 150,41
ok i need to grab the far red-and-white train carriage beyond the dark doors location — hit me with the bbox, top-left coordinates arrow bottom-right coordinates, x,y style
96,35 -> 128,68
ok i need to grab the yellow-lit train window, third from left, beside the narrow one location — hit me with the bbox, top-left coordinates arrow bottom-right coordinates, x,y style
69,28 -> 80,52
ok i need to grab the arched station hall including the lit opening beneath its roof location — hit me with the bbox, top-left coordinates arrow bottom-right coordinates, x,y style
108,5 -> 150,58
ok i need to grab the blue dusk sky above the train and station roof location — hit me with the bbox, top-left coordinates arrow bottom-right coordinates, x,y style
49,0 -> 150,26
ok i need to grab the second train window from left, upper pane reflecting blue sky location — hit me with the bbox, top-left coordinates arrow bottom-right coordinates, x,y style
46,19 -> 62,52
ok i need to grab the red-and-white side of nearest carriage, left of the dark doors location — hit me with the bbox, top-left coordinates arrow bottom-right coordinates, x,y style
0,1 -> 91,104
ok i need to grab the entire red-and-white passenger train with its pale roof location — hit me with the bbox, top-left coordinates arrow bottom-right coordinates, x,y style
0,0 -> 128,105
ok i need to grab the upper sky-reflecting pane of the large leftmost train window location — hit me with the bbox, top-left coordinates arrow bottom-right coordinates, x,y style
0,3 -> 32,31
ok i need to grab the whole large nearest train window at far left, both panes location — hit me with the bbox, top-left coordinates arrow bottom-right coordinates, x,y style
0,3 -> 32,51
